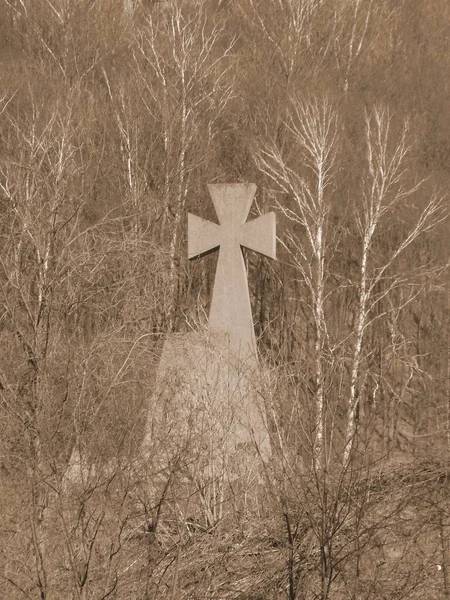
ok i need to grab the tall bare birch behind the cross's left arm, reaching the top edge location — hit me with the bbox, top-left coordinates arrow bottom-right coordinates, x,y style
135,2 -> 234,330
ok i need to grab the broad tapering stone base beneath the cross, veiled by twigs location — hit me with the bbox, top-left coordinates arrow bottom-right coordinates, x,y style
144,333 -> 270,476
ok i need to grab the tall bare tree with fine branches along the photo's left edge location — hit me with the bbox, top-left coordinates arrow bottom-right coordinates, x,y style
0,89 -> 91,597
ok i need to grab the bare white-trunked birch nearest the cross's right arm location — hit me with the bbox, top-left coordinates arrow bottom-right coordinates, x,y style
256,100 -> 338,467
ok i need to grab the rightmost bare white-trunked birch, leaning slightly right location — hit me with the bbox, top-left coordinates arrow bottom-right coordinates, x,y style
343,109 -> 444,464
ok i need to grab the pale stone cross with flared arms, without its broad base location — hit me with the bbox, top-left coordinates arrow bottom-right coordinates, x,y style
188,183 -> 276,357
